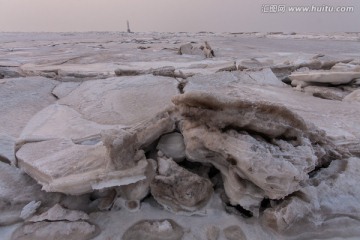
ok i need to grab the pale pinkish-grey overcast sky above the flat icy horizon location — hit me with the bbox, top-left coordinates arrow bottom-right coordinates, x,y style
0,0 -> 360,32
